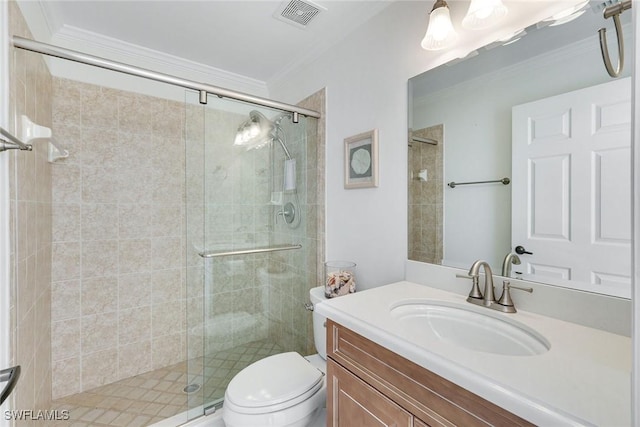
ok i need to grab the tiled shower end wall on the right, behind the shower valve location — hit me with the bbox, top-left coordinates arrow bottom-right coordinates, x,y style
269,90 -> 325,354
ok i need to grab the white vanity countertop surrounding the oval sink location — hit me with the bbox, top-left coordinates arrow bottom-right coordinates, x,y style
315,281 -> 632,427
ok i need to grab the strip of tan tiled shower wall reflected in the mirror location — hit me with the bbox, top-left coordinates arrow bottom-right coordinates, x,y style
408,125 -> 444,264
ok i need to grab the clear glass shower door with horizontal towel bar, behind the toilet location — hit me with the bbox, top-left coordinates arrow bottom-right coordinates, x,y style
186,89 -> 317,422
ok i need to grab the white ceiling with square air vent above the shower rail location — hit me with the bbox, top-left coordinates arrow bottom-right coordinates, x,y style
32,0 -> 396,82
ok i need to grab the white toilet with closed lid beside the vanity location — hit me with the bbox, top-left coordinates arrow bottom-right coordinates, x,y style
222,286 -> 327,427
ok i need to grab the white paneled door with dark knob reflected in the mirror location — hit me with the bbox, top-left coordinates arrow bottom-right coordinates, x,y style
511,78 -> 632,297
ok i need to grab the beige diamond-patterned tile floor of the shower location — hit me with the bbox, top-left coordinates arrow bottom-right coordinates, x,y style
49,341 -> 282,427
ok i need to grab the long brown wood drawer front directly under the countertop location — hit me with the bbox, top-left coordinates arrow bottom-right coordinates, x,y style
327,320 -> 533,427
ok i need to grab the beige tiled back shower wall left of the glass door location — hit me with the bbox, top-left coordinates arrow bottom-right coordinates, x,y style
51,78 -> 186,398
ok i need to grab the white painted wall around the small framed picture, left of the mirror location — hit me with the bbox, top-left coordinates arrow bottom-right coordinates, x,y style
269,1 -> 576,288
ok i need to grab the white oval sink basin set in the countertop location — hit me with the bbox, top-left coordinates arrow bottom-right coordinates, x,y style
391,301 -> 551,356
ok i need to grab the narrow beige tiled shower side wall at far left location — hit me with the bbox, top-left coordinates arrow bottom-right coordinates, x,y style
7,1 -> 52,418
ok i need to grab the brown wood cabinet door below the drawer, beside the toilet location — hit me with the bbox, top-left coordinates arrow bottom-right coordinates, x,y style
327,359 -> 413,427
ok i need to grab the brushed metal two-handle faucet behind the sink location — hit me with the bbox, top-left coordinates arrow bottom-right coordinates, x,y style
458,260 -> 533,313
